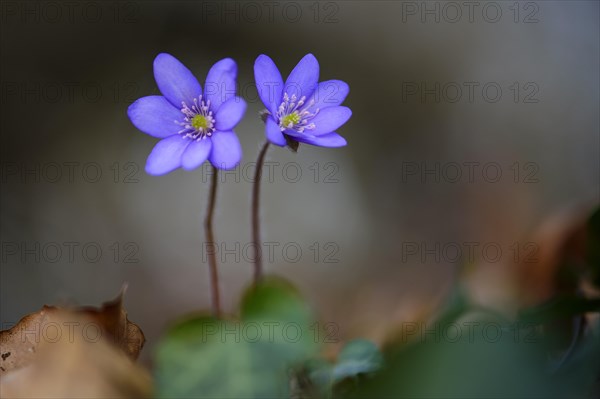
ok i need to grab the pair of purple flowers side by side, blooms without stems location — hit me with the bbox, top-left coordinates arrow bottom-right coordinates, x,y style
128,53 -> 352,175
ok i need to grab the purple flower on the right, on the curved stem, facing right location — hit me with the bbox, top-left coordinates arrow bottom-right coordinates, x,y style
254,54 -> 352,147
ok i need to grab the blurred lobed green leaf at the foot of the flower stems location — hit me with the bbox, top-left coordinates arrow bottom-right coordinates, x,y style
156,278 -> 317,398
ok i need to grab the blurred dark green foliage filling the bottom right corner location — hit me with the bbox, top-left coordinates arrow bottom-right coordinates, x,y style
344,266 -> 600,399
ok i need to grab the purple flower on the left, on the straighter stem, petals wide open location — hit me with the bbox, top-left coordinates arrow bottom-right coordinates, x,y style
127,53 -> 246,175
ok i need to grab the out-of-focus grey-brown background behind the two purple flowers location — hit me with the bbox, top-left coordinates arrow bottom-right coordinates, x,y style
0,1 -> 600,361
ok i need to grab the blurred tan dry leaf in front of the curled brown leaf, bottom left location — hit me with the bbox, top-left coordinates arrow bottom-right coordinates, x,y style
0,314 -> 152,398
